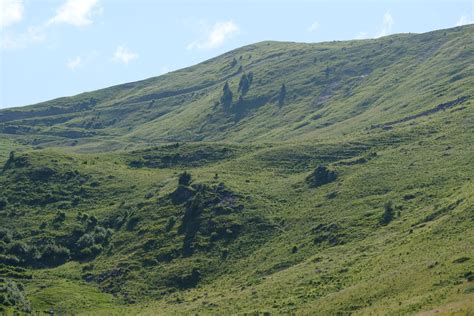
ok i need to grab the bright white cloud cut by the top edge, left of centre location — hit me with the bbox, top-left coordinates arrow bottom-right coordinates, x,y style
48,0 -> 102,27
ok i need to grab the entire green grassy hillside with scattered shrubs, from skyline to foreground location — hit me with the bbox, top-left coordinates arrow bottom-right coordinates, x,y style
0,25 -> 474,315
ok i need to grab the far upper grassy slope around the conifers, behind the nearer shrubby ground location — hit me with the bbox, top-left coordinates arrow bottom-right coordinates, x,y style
0,25 -> 474,145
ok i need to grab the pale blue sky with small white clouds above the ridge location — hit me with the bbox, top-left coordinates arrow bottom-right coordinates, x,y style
0,0 -> 474,108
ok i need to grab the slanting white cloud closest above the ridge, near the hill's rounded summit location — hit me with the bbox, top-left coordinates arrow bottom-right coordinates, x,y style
187,21 -> 240,50
